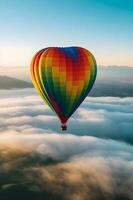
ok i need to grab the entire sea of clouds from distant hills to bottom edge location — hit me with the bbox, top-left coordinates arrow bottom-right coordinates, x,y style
0,89 -> 133,200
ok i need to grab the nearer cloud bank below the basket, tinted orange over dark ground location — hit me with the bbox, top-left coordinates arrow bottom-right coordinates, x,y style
0,133 -> 133,200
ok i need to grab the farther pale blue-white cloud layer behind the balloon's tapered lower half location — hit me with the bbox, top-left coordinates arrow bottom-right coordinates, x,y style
0,89 -> 133,144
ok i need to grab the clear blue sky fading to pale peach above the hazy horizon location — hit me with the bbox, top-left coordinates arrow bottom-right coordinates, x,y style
0,0 -> 133,66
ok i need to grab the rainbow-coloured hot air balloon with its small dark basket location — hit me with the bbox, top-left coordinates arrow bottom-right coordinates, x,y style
30,47 -> 97,130
